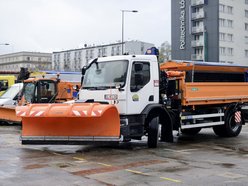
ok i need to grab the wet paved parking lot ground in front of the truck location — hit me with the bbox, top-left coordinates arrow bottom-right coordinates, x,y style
0,126 -> 248,186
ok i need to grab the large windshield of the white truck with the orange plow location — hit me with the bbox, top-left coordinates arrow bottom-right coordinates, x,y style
83,60 -> 128,89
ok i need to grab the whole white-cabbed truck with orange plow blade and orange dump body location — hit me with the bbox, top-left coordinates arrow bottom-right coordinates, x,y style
16,55 -> 248,148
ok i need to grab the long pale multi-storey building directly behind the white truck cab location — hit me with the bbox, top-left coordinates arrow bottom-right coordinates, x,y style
52,41 -> 154,71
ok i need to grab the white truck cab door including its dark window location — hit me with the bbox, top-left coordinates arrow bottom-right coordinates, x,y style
127,61 -> 155,114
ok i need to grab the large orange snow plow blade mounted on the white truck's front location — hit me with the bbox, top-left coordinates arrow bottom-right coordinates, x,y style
16,103 -> 120,144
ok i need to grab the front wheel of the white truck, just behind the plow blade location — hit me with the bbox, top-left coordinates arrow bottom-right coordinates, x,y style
147,117 -> 159,148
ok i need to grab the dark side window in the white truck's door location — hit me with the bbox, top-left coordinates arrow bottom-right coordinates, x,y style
130,61 -> 151,92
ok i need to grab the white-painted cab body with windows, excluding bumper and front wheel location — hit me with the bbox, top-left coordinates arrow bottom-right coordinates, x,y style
79,55 -> 159,115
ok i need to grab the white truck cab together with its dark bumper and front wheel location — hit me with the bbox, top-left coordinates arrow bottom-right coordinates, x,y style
79,55 -> 170,147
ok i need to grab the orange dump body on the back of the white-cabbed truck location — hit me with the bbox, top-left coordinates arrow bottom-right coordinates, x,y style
160,61 -> 248,106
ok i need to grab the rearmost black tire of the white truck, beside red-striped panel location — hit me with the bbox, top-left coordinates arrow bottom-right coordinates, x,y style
213,111 -> 242,137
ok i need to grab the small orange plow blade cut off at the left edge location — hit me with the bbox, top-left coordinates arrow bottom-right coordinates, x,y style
0,105 -> 22,123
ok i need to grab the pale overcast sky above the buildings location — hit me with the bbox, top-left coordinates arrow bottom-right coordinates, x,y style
0,0 -> 171,54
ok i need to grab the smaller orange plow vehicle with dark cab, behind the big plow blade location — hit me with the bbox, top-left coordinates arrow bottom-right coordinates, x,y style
0,78 -> 78,123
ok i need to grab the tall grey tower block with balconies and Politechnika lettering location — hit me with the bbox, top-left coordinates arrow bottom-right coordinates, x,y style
171,0 -> 248,65
